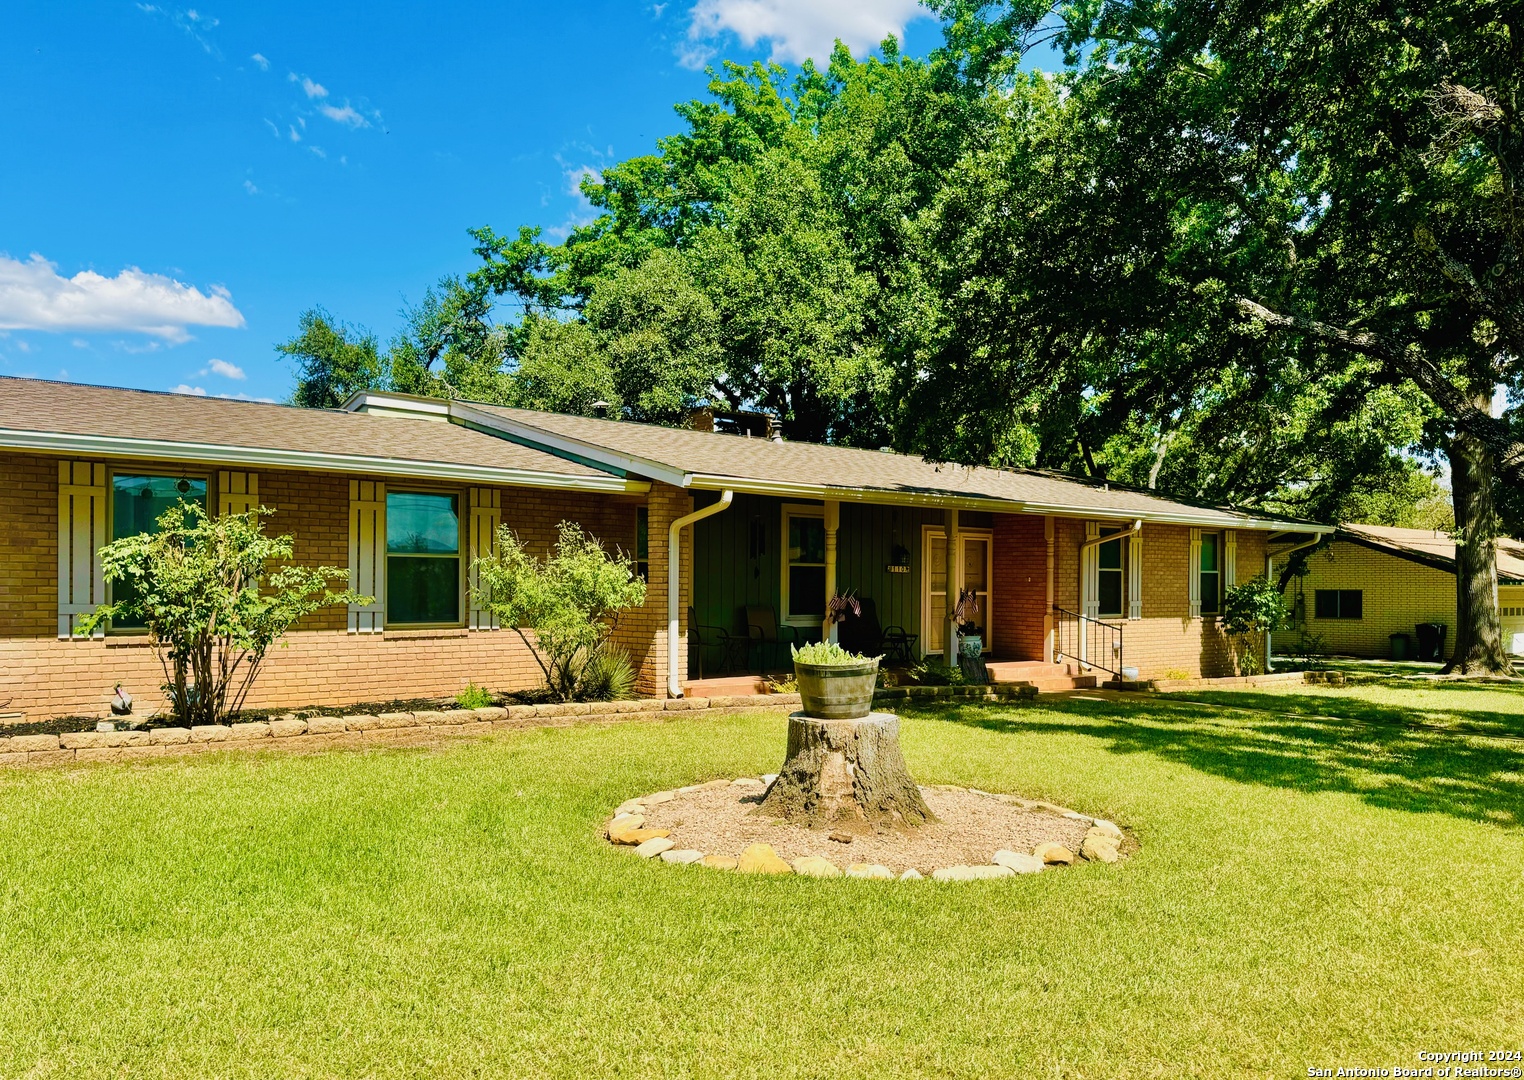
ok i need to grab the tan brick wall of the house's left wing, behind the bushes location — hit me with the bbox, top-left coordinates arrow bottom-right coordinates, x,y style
0,454 -> 692,719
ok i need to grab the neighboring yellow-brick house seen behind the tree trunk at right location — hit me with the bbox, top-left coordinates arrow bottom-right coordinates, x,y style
1276,526 -> 1524,657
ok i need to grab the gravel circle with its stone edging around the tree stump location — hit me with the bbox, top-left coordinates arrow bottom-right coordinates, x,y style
605,775 -> 1138,880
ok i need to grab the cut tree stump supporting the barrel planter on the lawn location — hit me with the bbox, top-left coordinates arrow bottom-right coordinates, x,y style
757,713 -> 936,830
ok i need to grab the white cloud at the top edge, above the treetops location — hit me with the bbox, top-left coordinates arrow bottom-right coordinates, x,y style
678,0 -> 931,67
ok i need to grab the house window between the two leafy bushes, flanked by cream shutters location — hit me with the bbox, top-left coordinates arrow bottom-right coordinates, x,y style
386,490 -> 460,626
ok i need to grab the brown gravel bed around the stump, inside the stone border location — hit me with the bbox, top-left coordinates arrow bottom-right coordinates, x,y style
645,788 -> 1090,876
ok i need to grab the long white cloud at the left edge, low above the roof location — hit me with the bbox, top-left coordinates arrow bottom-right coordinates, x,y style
0,253 -> 244,341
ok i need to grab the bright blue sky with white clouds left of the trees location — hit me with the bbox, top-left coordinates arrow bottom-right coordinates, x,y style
0,0 -> 937,399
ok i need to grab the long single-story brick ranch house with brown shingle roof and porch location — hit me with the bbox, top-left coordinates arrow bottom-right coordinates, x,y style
0,378 -> 1326,719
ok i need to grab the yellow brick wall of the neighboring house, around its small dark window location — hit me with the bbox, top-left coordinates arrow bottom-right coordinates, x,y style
1276,541 -> 1455,658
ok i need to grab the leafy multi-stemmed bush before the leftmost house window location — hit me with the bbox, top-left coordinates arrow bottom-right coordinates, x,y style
78,501 -> 361,724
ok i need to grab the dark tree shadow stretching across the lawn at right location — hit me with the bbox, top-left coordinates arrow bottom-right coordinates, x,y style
928,687 -> 1524,826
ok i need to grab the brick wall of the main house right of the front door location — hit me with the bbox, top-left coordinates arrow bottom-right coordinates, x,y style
994,515 -> 1266,679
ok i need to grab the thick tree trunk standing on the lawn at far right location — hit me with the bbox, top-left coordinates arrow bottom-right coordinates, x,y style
1445,433 -> 1513,675
